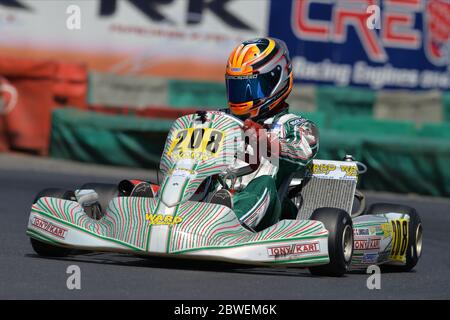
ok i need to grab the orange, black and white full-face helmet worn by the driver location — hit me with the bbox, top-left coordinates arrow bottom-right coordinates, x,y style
225,38 -> 293,120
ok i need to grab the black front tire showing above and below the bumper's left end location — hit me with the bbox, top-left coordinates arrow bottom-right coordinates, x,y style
30,188 -> 74,257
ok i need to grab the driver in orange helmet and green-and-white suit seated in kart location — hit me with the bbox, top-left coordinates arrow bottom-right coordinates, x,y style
213,38 -> 319,231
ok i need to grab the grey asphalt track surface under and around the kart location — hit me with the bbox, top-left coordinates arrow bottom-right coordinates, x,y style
0,157 -> 450,300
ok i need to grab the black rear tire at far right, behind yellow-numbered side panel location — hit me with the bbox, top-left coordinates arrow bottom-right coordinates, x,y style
366,203 -> 423,272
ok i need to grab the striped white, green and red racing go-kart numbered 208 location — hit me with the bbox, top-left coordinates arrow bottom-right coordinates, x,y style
27,111 -> 422,276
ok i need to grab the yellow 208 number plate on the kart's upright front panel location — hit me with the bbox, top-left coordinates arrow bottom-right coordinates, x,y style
168,128 -> 225,160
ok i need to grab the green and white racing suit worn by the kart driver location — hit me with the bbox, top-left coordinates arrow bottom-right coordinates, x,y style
233,109 -> 319,231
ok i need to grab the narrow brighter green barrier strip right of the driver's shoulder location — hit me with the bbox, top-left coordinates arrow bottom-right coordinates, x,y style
332,116 -> 416,136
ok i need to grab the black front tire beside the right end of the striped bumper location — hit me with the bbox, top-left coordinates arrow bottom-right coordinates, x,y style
309,208 -> 353,277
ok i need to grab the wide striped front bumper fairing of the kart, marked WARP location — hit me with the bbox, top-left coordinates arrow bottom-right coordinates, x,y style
29,197 -> 328,263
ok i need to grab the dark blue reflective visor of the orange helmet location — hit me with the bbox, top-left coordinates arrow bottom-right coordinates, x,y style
226,75 -> 276,103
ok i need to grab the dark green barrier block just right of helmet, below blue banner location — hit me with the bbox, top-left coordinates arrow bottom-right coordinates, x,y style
316,86 -> 376,126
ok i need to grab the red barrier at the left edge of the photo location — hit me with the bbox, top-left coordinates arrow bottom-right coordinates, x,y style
0,58 -> 87,155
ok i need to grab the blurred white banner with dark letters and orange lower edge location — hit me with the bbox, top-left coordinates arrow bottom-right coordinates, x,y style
0,0 -> 270,81
